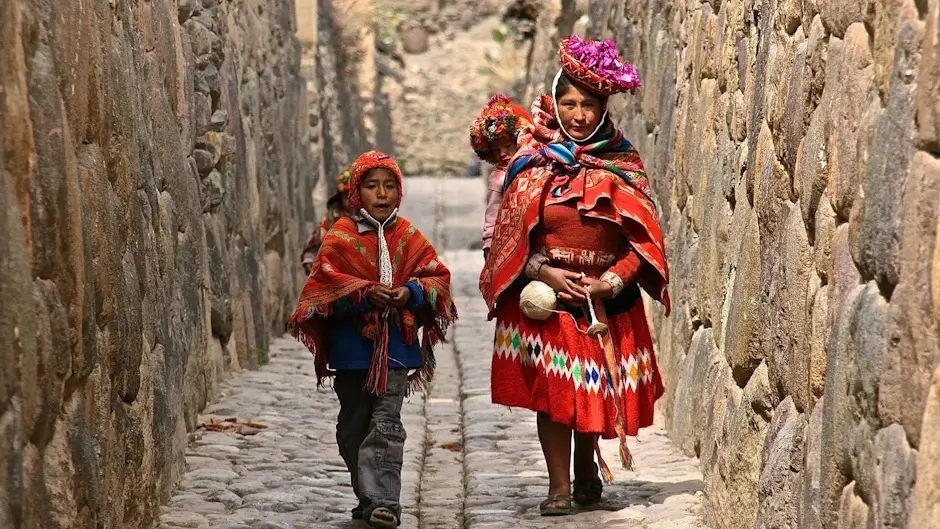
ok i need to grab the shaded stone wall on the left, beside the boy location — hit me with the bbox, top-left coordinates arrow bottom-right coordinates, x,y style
0,0 -> 319,529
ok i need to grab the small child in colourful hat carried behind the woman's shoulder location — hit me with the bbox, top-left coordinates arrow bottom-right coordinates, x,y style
470,95 -> 532,258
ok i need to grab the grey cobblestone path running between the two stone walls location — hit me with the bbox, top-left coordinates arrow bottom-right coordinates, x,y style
159,178 -> 706,529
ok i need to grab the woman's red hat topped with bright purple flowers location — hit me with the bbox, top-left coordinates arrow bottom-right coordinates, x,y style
558,35 -> 641,97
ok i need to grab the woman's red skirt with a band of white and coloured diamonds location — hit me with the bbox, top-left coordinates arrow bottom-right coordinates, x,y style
490,287 -> 663,439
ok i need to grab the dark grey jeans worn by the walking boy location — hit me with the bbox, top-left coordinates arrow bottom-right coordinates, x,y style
334,369 -> 408,520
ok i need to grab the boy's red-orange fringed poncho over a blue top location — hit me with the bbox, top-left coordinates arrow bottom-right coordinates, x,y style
290,217 -> 457,394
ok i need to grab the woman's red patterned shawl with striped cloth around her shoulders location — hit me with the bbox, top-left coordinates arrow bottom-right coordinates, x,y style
480,96 -> 670,318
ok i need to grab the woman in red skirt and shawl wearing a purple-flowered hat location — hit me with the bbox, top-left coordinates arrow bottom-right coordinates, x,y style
480,36 -> 669,516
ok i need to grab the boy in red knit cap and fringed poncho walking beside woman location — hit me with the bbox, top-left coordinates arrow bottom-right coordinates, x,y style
291,151 -> 457,528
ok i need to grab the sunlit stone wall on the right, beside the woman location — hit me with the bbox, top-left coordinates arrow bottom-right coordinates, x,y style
516,0 -> 940,528
